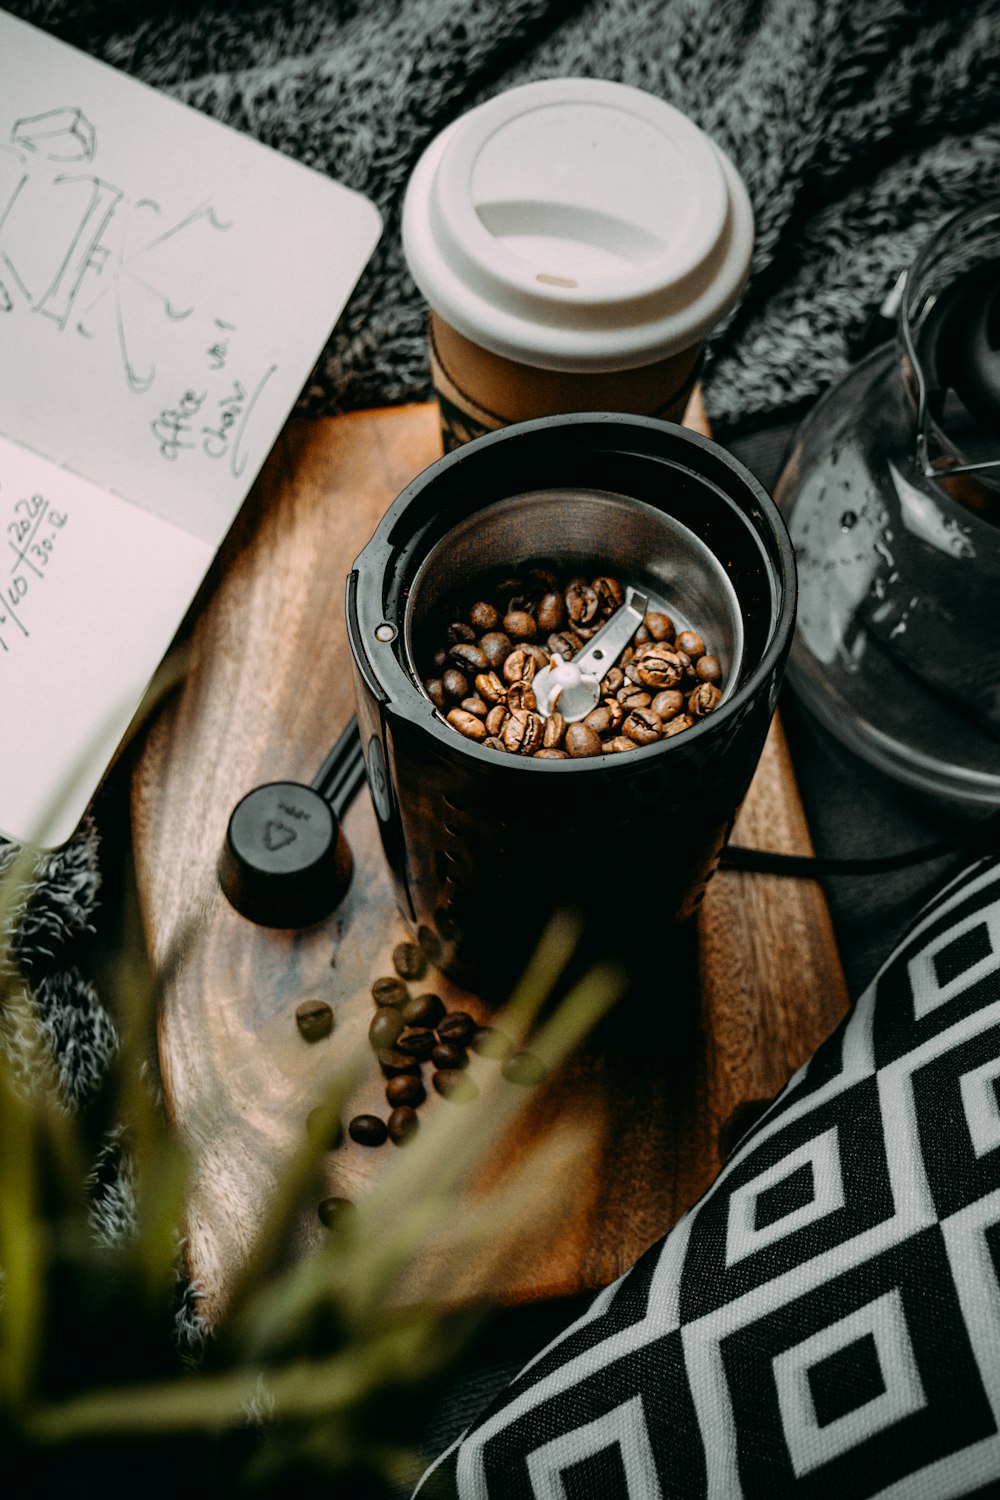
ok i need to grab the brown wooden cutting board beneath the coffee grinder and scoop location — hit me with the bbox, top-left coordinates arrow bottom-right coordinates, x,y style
132,402 -> 847,1320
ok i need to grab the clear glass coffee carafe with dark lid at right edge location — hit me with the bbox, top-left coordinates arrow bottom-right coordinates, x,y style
775,200 -> 1000,809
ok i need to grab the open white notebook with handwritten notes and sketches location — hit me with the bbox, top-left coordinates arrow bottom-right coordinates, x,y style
0,12 -> 381,846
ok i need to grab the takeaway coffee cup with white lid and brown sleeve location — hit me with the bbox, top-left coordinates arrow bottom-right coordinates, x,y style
403,78 -> 753,449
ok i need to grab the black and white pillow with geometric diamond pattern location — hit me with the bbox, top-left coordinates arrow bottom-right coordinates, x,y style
417,857 -> 1000,1500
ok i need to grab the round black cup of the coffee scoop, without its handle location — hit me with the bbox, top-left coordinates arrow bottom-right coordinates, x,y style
219,782 -> 352,927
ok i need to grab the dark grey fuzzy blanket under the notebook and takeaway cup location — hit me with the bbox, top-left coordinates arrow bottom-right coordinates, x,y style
9,0 -> 1000,1116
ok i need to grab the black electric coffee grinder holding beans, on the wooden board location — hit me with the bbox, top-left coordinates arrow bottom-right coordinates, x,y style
346,413 -> 796,999
